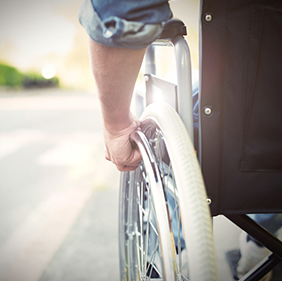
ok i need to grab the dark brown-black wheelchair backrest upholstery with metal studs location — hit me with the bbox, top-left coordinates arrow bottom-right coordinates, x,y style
200,0 -> 282,215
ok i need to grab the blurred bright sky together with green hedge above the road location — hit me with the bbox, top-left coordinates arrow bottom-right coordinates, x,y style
0,0 -> 198,90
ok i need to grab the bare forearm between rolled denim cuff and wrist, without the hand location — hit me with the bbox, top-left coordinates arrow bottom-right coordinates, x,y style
89,39 -> 145,132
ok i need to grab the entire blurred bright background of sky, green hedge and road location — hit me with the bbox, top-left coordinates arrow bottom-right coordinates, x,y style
0,0 -> 242,281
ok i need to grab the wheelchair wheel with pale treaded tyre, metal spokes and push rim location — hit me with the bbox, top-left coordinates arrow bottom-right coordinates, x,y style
119,103 -> 217,281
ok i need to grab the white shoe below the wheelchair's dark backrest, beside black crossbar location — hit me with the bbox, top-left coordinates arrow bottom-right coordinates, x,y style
237,232 -> 272,281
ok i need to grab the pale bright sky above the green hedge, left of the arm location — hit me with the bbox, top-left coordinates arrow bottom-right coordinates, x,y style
0,0 -> 93,88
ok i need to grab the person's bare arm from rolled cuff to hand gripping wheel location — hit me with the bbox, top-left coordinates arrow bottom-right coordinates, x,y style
89,39 -> 145,171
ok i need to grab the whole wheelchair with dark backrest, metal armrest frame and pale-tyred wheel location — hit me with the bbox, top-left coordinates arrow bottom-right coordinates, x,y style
119,0 -> 282,281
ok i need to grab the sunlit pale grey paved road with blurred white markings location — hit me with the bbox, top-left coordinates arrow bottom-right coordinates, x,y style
0,90 -> 243,281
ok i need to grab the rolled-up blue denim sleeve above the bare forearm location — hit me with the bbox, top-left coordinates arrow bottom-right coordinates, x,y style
79,0 -> 172,49
